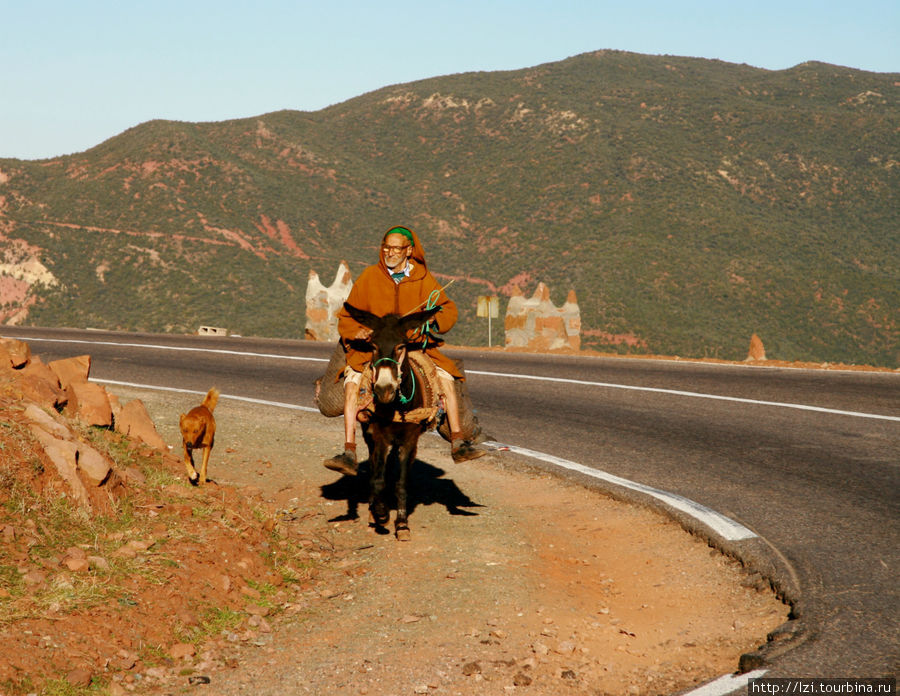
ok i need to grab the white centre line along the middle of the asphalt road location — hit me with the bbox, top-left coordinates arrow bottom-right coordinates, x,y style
17,337 -> 900,423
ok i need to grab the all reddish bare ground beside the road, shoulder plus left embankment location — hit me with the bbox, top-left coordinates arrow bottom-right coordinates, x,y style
0,378 -> 787,696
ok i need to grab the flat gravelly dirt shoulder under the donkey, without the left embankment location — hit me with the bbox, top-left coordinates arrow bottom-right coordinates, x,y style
96,386 -> 787,696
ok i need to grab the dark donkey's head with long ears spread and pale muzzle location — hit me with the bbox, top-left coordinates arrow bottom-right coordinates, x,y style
344,302 -> 440,404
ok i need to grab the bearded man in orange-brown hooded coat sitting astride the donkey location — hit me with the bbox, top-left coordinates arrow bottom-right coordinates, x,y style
325,227 -> 486,476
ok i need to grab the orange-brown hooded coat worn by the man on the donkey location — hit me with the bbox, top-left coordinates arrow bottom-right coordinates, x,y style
338,228 -> 463,379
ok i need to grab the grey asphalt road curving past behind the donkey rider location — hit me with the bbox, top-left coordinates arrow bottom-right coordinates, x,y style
0,327 -> 900,677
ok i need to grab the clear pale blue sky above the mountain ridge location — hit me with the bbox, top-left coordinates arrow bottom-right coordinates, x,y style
0,0 -> 900,159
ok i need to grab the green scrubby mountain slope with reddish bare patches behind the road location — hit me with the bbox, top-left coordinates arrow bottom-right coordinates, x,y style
0,51 -> 900,367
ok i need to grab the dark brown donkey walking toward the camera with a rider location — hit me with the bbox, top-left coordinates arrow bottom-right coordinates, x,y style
344,303 -> 440,541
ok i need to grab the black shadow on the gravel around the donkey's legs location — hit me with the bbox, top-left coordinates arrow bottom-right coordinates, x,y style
321,459 -> 484,522
